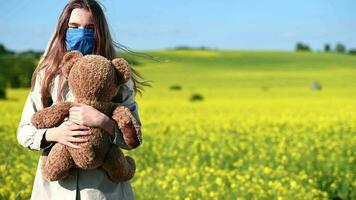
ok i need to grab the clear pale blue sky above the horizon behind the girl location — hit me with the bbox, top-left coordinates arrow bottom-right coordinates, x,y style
0,0 -> 356,51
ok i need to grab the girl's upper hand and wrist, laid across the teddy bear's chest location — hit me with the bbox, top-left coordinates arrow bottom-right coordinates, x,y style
69,103 -> 106,127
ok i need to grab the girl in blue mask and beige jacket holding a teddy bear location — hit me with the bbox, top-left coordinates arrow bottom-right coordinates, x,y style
17,0 -> 147,200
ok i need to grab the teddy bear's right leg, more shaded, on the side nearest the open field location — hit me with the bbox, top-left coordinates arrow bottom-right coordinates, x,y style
102,146 -> 136,182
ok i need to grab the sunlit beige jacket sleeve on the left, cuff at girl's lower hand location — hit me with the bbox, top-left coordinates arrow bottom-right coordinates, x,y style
16,70 -> 53,151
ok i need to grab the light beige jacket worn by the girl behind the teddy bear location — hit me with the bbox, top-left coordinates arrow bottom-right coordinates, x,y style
17,70 -> 141,200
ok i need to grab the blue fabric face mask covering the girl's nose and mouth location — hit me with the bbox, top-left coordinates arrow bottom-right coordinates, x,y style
66,28 -> 95,55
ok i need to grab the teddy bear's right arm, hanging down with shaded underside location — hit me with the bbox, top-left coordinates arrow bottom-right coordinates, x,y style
112,106 -> 141,148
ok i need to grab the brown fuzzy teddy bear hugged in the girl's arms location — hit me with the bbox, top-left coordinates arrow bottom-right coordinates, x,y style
31,50 -> 141,182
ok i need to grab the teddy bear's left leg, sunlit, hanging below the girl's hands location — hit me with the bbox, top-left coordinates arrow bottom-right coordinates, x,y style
41,143 -> 74,181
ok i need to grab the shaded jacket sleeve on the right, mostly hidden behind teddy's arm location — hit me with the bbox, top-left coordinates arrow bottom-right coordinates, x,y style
111,79 -> 142,150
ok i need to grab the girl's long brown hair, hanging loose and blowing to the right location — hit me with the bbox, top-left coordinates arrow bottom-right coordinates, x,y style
31,0 -> 150,107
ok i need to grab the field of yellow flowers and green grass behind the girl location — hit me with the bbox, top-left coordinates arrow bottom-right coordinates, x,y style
0,50 -> 356,199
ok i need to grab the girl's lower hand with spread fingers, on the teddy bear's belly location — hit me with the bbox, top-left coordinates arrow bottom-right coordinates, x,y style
45,121 -> 91,148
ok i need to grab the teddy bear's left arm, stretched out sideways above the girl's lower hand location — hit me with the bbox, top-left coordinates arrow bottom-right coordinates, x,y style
31,102 -> 72,128
